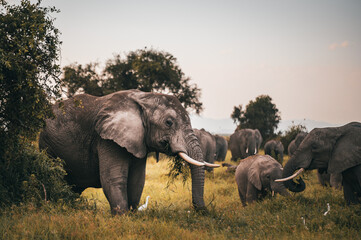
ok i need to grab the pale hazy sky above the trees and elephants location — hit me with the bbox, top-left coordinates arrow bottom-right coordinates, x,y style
19,0 -> 361,124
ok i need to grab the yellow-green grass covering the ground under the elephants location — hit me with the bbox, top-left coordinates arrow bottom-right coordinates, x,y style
0,151 -> 361,239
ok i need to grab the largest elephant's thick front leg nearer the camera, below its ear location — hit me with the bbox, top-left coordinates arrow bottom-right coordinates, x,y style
98,140 -> 133,214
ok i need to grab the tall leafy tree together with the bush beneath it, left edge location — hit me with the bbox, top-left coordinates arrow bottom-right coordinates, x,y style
0,0 -> 75,205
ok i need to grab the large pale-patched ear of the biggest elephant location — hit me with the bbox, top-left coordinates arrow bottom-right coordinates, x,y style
95,91 -> 147,158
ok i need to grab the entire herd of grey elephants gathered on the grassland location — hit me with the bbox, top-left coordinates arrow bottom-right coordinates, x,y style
39,90 -> 361,214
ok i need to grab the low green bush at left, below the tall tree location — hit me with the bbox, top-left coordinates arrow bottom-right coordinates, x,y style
0,141 -> 79,206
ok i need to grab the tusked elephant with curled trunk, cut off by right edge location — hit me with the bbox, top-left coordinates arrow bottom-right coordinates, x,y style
277,122 -> 361,205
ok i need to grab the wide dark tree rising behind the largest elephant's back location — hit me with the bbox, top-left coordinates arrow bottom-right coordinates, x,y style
62,48 -> 202,113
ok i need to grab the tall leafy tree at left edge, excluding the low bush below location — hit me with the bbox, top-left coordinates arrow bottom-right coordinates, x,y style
0,0 -> 60,141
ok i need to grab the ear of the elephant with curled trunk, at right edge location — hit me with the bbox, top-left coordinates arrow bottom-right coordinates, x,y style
328,127 -> 361,173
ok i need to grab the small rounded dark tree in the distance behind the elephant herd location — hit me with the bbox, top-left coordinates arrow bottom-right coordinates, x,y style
231,95 -> 281,141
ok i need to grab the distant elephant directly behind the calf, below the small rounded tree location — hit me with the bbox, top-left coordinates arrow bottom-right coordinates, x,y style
229,128 -> 263,161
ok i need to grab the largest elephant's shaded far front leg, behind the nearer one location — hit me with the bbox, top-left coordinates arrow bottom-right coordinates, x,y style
128,158 -> 146,210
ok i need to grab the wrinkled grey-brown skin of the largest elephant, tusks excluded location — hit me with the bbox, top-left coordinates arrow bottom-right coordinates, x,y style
39,90 -> 205,214
